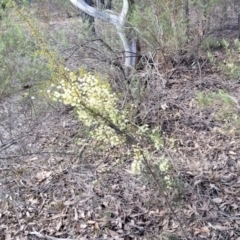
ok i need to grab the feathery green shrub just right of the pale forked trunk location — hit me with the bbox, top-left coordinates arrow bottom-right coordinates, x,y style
130,0 -> 187,53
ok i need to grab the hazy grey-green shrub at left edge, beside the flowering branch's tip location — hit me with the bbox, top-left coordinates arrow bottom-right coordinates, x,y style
0,6 -> 50,98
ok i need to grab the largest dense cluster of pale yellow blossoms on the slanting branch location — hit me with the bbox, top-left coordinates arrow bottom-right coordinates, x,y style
49,69 -> 128,146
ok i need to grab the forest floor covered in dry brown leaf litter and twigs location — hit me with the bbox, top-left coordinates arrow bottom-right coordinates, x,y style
0,3 -> 240,240
